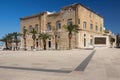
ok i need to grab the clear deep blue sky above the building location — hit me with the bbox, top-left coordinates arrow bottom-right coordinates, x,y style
0,0 -> 120,38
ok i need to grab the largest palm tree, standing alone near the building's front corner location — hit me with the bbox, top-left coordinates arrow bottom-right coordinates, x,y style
63,24 -> 78,49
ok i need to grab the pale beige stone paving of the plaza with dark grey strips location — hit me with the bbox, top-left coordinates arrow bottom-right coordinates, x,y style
0,48 -> 120,80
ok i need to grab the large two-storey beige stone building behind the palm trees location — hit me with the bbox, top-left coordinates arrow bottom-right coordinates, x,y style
20,4 -> 104,49
